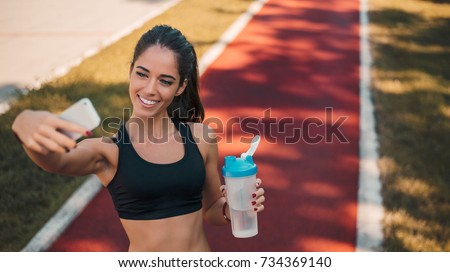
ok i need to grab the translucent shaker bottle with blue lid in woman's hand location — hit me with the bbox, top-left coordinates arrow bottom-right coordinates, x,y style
222,151 -> 259,238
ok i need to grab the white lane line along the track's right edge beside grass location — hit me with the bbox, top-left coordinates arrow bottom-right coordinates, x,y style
356,0 -> 384,251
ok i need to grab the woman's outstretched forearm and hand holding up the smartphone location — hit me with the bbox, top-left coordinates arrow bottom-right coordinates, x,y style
12,110 -> 108,176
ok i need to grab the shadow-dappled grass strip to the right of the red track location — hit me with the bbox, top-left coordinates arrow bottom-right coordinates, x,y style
369,0 -> 450,251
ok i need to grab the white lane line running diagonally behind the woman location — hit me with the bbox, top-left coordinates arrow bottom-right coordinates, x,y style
22,0 -> 268,251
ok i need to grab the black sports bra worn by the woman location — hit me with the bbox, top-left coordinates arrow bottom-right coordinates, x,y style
107,119 -> 205,220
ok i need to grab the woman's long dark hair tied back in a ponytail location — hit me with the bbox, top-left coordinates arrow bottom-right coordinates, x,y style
130,25 -> 205,123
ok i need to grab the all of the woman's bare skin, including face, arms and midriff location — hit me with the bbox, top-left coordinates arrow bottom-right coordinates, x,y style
13,45 -> 265,251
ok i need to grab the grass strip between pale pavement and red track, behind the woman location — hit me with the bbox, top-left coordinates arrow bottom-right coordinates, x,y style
0,0 -> 252,251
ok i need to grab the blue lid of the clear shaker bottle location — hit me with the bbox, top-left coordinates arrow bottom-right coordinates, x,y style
222,156 -> 258,178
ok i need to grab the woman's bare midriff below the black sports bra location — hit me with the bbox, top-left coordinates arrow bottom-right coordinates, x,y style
120,210 -> 210,252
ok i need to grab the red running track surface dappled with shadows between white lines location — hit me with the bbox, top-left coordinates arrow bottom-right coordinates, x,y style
49,0 -> 359,251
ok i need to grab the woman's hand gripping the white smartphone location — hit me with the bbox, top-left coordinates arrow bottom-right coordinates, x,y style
12,110 -> 92,155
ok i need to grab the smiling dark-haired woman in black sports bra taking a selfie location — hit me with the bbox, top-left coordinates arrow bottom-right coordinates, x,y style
12,25 -> 264,251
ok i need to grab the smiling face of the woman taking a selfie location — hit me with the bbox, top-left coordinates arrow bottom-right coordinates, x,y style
129,45 -> 186,118
